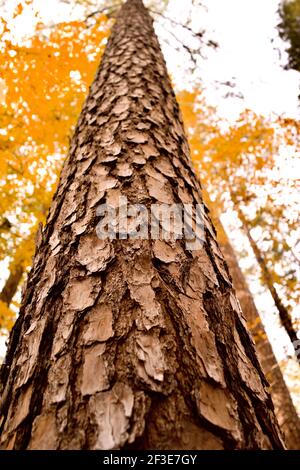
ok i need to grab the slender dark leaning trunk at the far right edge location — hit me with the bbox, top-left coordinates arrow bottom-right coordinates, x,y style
236,207 -> 300,364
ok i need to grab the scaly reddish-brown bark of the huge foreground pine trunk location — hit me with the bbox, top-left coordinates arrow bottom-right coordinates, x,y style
0,0 -> 283,449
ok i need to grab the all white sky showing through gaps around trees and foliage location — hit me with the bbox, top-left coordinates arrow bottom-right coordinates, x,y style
0,0 -> 300,406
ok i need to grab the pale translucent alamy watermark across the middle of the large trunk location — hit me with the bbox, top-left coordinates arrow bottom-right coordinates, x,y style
96,196 -> 205,250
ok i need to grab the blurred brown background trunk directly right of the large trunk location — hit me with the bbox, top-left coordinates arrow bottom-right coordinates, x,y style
213,212 -> 300,450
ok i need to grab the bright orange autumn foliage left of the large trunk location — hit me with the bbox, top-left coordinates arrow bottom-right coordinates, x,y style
0,0 -> 110,330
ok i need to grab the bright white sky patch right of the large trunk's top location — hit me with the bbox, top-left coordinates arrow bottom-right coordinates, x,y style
158,0 -> 299,119
